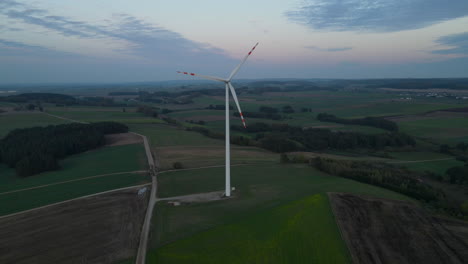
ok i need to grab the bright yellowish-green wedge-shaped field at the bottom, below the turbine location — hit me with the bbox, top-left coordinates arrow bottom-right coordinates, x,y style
148,194 -> 351,263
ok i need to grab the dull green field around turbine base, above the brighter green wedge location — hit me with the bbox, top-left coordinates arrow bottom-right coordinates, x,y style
150,164 -> 408,258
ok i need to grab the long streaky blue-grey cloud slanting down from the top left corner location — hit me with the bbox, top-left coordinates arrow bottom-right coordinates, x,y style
0,0 -> 234,66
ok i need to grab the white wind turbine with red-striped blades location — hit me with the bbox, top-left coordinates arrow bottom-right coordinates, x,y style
178,43 -> 258,197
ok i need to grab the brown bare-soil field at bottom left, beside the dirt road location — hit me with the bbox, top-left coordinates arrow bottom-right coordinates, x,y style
0,188 -> 149,264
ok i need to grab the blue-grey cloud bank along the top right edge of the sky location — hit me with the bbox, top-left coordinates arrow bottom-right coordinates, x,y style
286,0 -> 468,32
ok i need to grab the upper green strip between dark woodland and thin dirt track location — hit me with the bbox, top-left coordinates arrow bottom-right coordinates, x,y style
0,144 -> 147,193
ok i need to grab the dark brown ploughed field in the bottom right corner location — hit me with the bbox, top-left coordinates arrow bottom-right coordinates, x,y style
329,193 -> 468,264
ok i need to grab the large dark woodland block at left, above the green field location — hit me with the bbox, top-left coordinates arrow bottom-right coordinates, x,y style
0,122 -> 128,177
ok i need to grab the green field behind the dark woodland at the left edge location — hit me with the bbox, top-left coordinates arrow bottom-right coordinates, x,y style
0,112 -> 69,138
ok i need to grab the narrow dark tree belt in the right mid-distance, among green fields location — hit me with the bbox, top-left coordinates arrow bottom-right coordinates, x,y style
317,113 -> 398,132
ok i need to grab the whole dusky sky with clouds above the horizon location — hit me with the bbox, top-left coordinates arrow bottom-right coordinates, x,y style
0,0 -> 468,84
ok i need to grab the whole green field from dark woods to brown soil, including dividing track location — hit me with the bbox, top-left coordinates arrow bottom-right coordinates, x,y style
0,144 -> 150,215
